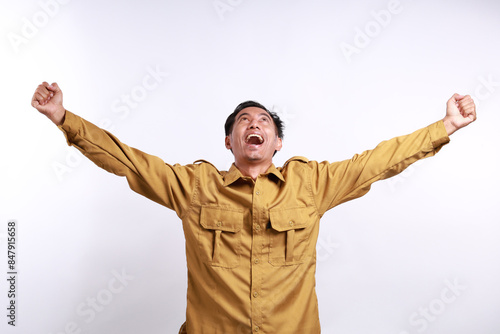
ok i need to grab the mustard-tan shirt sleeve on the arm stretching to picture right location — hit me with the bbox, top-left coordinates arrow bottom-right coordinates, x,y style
309,121 -> 450,215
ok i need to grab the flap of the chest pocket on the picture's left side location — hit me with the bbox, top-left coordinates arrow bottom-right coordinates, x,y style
200,206 -> 243,233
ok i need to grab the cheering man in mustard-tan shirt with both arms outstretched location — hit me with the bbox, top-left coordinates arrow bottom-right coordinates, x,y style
32,82 -> 476,334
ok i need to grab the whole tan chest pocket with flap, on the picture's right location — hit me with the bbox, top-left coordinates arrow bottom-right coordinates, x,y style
269,208 -> 312,266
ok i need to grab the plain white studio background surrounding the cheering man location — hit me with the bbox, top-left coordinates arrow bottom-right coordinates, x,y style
0,0 -> 500,334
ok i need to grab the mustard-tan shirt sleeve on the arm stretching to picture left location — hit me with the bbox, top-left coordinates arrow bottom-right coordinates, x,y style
59,111 -> 197,217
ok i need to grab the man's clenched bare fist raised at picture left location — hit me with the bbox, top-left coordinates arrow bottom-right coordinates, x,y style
31,82 -> 66,125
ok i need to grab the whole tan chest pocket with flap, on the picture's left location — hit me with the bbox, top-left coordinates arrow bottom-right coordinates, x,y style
198,207 -> 243,268
